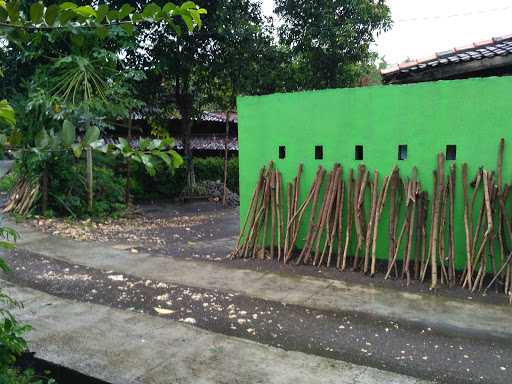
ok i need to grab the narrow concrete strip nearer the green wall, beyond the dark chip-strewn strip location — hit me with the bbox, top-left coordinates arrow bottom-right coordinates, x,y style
11,220 -> 512,341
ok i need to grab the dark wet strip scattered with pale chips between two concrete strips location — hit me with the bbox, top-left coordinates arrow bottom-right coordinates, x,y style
2,250 -> 512,384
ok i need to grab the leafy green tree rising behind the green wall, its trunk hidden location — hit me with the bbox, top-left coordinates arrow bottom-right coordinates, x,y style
274,0 -> 391,90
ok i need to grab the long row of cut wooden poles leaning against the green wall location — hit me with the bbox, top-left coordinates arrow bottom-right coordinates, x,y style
232,139 -> 512,302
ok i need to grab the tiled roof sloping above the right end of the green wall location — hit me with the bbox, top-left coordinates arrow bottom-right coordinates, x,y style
380,35 -> 512,80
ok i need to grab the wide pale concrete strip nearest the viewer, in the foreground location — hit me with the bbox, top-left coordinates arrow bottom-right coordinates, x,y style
0,280 -> 427,384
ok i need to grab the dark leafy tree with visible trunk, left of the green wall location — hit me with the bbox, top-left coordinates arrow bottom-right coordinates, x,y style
130,0 -> 275,187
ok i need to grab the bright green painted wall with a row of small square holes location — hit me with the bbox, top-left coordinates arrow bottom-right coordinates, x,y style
238,77 -> 512,266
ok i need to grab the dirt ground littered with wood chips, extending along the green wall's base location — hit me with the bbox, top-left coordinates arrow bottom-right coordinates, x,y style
31,202 -> 507,304
